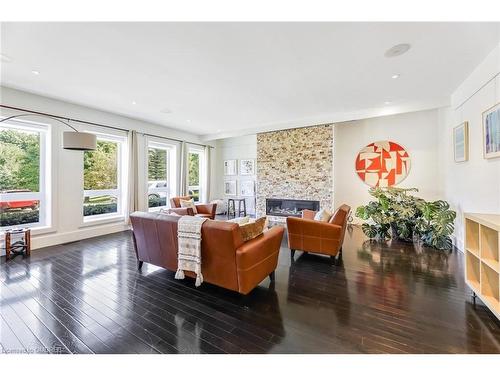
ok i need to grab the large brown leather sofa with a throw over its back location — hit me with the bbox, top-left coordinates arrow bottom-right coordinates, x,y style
130,212 -> 284,294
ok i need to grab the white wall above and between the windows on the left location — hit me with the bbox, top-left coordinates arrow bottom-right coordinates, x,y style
0,87 -> 215,248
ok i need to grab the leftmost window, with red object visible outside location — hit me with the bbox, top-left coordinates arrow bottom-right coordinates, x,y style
0,121 -> 50,229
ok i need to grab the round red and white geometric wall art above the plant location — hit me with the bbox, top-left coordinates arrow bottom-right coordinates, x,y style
356,141 -> 410,187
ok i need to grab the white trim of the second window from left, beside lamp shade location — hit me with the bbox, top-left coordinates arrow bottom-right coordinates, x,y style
79,132 -> 128,228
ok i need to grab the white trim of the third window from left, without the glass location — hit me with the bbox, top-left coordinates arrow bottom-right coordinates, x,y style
144,137 -> 178,212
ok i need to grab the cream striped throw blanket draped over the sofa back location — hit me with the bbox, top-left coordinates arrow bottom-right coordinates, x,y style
175,216 -> 207,286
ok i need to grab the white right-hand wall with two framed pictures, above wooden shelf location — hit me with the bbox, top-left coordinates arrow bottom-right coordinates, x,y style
439,45 -> 500,250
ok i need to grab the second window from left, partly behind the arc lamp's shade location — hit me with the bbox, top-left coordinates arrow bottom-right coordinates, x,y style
83,135 -> 126,221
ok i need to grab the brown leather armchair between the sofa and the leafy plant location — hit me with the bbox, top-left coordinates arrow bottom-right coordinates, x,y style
286,204 -> 351,259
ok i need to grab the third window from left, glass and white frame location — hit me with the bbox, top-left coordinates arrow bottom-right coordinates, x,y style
147,141 -> 176,210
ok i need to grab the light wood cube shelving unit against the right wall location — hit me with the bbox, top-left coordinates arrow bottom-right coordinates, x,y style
465,214 -> 500,319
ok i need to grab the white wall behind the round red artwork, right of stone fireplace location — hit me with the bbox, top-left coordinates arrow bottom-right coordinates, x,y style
333,110 -> 442,222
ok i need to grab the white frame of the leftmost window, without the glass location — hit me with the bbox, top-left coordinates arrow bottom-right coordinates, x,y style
0,116 -> 53,232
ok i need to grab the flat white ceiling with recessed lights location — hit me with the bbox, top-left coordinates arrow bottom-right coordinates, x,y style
0,23 -> 500,139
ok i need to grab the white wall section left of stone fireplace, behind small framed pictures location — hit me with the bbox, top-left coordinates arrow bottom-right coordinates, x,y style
214,135 -> 257,214
